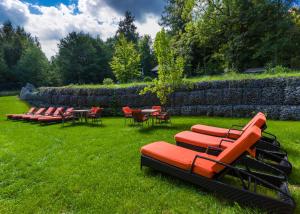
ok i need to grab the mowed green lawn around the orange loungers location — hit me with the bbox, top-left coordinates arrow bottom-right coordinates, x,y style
0,97 -> 300,213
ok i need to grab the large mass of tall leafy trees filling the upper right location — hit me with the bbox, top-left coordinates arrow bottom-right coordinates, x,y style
163,0 -> 300,75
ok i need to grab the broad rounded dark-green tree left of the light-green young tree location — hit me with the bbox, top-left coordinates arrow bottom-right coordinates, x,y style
56,32 -> 112,84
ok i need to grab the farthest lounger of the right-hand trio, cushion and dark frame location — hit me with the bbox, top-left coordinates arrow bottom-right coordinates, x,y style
191,112 -> 280,149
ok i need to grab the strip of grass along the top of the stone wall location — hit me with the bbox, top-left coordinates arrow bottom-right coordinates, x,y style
55,71 -> 300,88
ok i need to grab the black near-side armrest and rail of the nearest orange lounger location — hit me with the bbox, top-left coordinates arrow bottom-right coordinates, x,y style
190,155 -> 294,202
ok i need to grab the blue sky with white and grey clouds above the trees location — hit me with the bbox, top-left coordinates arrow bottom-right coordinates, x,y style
0,0 -> 165,58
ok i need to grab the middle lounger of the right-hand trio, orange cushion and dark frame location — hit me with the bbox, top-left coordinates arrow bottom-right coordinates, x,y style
174,119 -> 292,174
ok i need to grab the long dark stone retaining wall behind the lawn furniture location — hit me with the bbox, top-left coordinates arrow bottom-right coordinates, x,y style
22,78 -> 300,120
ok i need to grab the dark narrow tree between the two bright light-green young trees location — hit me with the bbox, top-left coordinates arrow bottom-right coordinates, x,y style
138,35 -> 156,76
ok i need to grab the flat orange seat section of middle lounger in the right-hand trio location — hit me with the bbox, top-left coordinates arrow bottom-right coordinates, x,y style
175,131 -> 234,148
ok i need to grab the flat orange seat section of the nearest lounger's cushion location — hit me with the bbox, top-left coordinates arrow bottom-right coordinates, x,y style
141,141 -> 216,178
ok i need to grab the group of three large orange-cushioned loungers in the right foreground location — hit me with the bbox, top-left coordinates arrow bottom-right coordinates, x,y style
141,113 -> 295,213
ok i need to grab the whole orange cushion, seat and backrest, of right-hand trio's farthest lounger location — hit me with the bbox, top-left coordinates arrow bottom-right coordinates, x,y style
191,112 -> 267,139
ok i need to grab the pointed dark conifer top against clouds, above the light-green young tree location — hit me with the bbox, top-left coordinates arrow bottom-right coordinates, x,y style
117,11 -> 138,43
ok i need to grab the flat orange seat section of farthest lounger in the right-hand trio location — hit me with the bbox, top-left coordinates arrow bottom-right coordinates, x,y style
191,124 -> 242,139
